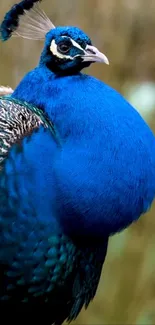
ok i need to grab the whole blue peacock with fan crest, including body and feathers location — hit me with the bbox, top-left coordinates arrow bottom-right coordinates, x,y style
0,0 -> 155,325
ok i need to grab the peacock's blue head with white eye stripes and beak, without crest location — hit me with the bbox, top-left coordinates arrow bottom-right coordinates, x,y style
40,27 -> 109,74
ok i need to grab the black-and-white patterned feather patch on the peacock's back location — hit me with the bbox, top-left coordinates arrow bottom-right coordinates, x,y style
0,96 -> 57,167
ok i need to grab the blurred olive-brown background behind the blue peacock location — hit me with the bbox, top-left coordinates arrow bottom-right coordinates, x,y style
0,0 -> 155,325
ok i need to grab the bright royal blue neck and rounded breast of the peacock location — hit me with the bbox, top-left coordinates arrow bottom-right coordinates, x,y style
13,66 -> 155,237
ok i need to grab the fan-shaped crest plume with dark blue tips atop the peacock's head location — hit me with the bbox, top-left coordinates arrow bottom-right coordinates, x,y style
0,0 -> 55,41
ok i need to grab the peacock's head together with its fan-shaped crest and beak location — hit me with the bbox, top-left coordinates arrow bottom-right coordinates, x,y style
0,0 -> 109,74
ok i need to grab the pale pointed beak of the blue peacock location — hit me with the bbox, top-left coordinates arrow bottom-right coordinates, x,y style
82,45 -> 109,64
